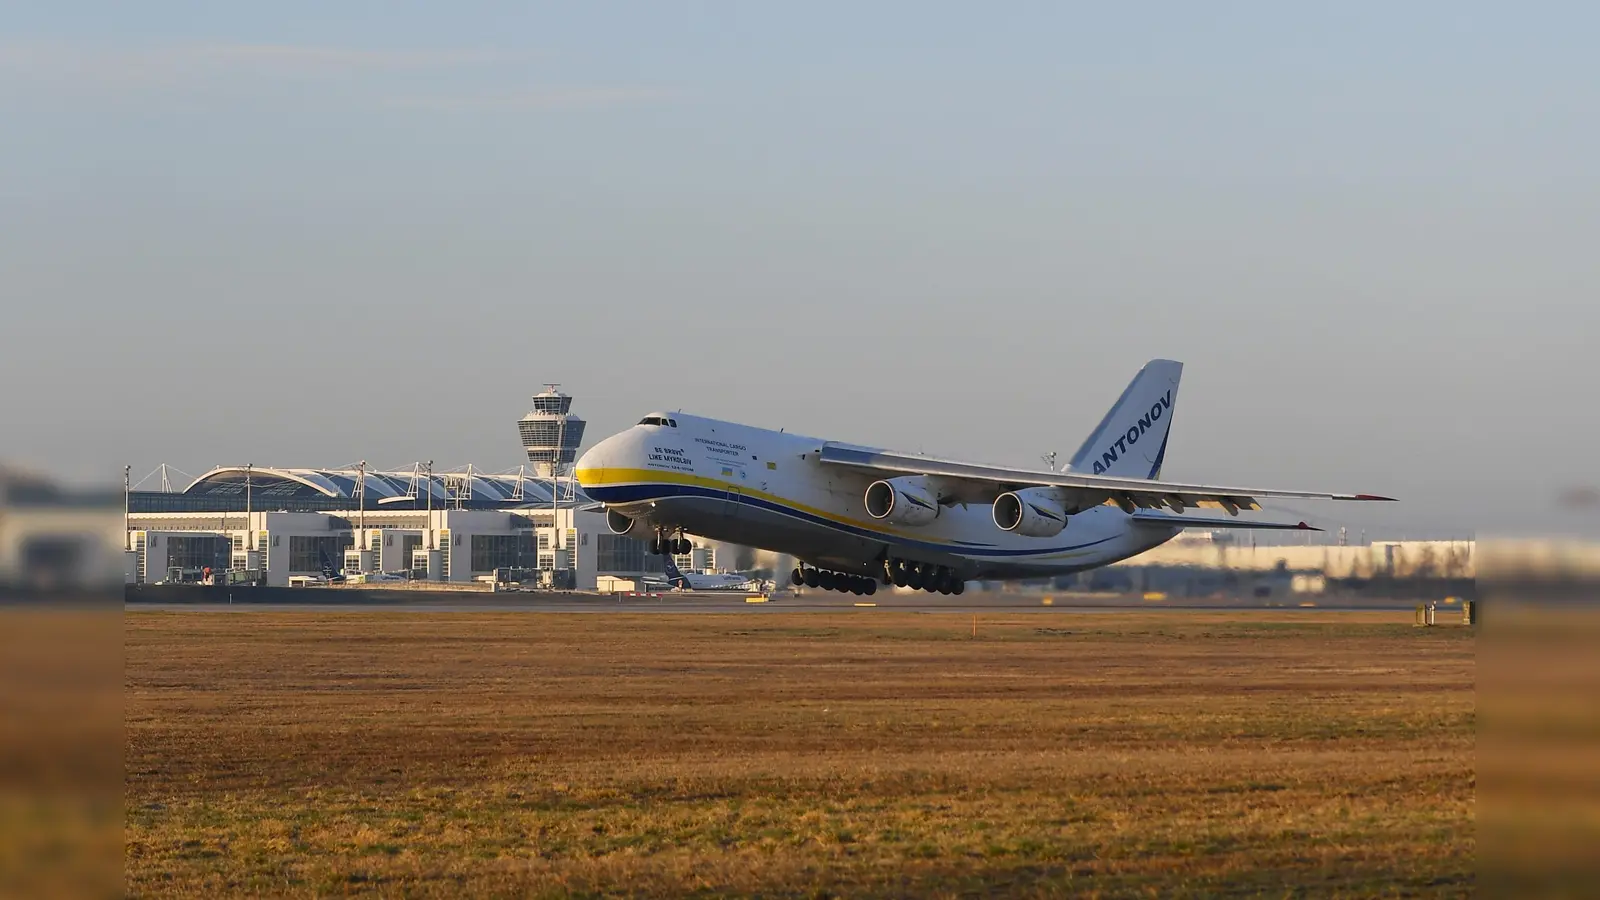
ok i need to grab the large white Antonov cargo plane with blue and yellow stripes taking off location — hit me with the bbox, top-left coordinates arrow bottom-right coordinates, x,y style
576,359 -> 1390,594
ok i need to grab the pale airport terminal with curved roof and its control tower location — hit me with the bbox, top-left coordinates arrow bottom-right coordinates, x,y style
123,386 -> 675,591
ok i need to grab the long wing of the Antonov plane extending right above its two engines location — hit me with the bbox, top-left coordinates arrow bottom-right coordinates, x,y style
818,442 -> 1394,516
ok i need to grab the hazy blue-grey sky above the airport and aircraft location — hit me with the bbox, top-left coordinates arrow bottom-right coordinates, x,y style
0,2 -> 1600,532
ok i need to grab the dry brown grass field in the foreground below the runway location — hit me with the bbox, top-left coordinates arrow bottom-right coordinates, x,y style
125,610 -> 1475,897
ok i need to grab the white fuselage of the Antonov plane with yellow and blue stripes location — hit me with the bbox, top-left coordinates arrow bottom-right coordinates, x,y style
576,413 -> 1181,580
